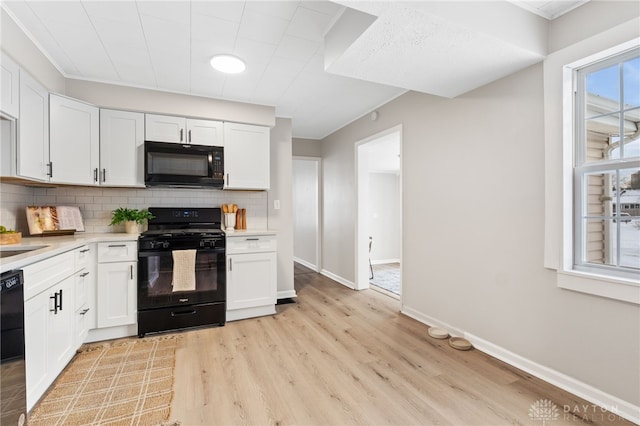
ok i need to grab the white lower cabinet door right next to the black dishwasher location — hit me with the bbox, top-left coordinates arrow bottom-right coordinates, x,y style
24,291 -> 49,410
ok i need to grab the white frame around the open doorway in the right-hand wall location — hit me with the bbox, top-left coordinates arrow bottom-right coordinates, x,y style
354,124 -> 404,294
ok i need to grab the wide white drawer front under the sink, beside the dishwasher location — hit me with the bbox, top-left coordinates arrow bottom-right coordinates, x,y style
23,251 -> 75,300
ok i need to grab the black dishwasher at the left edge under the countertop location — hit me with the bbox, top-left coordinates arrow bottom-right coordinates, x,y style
0,270 -> 27,426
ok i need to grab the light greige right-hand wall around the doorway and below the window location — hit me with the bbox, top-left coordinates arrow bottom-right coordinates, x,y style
322,4 -> 640,412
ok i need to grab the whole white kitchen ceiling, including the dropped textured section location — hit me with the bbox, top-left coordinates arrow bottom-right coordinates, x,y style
2,0 -> 585,139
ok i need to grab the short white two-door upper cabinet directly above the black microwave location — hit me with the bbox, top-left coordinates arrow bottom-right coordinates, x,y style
145,114 -> 223,146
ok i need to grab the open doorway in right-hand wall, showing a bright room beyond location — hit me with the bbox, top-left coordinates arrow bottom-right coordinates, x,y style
355,126 -> 402,299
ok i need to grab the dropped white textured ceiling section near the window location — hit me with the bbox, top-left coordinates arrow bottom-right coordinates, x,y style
326,3 -> 544,98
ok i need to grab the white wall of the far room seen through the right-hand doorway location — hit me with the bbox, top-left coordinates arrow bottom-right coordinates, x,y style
367,173 -> 402,264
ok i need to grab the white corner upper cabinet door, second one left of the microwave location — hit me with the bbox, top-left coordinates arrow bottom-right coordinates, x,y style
49,94 -> 100,185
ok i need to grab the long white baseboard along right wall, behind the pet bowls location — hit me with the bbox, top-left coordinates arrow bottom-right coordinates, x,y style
401,306 -> 640,424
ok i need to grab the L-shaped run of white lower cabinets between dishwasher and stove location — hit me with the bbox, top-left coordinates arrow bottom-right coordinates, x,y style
23,241 -> 138,410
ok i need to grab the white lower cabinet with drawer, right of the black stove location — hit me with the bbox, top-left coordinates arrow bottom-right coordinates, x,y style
226,235 -> 278,321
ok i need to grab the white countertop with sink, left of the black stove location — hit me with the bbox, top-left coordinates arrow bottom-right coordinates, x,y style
0,233 -> 138,273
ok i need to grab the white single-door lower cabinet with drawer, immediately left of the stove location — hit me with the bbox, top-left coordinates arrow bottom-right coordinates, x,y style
97,241 -> 138,328
